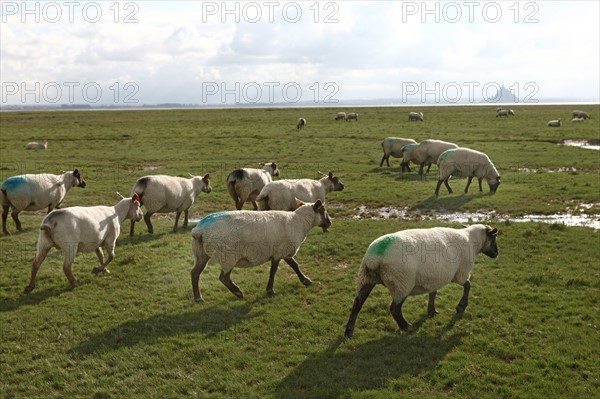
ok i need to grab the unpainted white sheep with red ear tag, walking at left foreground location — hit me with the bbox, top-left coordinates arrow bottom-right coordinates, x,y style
25,193 -> 142,294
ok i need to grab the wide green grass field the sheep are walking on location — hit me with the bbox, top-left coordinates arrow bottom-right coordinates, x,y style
0,105 -> 600,399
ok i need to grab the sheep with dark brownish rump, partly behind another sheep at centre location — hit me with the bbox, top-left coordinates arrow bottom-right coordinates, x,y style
227,162 -> 279,210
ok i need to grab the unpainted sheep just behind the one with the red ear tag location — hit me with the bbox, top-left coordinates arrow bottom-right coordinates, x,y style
129,174 -> 212,236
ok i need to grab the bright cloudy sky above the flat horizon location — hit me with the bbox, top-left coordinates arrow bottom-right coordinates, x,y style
0,0 -> 600,106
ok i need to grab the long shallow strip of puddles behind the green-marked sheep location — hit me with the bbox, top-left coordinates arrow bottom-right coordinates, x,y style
352,204 -> 600,230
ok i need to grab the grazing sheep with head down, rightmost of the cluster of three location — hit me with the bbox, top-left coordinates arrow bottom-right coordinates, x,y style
435,148 -> 500,196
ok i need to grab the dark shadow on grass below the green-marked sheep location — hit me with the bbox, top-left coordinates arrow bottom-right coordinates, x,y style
274,315 -> 466,399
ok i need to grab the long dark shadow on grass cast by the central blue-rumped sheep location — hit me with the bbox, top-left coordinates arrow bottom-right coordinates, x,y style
71,304 -> 260,355
